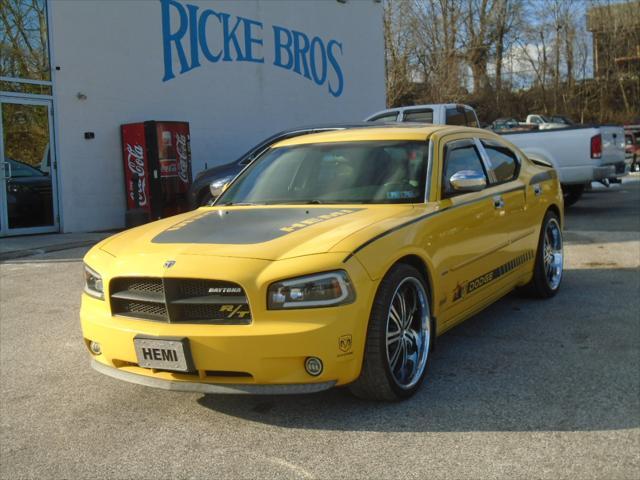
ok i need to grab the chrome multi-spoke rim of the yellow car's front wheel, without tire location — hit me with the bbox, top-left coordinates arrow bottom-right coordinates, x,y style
386,277 -> 431,389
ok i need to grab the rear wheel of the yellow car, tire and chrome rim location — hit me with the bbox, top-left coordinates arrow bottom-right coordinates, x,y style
524,210 -> 564,298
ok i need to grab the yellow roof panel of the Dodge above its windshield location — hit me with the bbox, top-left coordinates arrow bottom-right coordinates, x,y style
273,123 -> 487,148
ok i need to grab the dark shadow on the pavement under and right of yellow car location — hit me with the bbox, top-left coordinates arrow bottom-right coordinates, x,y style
198,269 -> 640,432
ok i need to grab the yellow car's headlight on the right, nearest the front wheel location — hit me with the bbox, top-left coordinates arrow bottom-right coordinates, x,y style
267,270 -> 356,310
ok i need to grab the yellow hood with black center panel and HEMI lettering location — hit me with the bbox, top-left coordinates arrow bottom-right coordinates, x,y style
99,205 -> 415,260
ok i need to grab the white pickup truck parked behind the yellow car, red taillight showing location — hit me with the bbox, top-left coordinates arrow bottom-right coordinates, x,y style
365,104 -> 627,205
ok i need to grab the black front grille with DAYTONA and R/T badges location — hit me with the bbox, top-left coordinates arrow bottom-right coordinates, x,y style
109,277 -> 251,325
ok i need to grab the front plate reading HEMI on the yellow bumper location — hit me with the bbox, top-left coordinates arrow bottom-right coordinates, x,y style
133,337 -> 194,372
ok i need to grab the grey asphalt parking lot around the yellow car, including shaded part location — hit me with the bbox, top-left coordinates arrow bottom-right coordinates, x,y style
0,176 -> 640,479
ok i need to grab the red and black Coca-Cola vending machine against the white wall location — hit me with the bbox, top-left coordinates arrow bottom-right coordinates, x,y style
121,121 -> 191,227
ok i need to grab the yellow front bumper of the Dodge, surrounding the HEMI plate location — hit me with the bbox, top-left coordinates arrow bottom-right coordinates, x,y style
80,253 -> 377,393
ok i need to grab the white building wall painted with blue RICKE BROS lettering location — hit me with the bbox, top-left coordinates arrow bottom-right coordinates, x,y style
49,0 -> 385,232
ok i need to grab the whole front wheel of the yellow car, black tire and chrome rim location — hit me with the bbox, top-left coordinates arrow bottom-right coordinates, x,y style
350,264 -> 434,401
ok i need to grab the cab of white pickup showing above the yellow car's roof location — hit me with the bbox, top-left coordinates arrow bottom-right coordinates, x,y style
365,103 -> 480,128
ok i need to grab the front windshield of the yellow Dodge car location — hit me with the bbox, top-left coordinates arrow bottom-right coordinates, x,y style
216,141 -> 428,205
